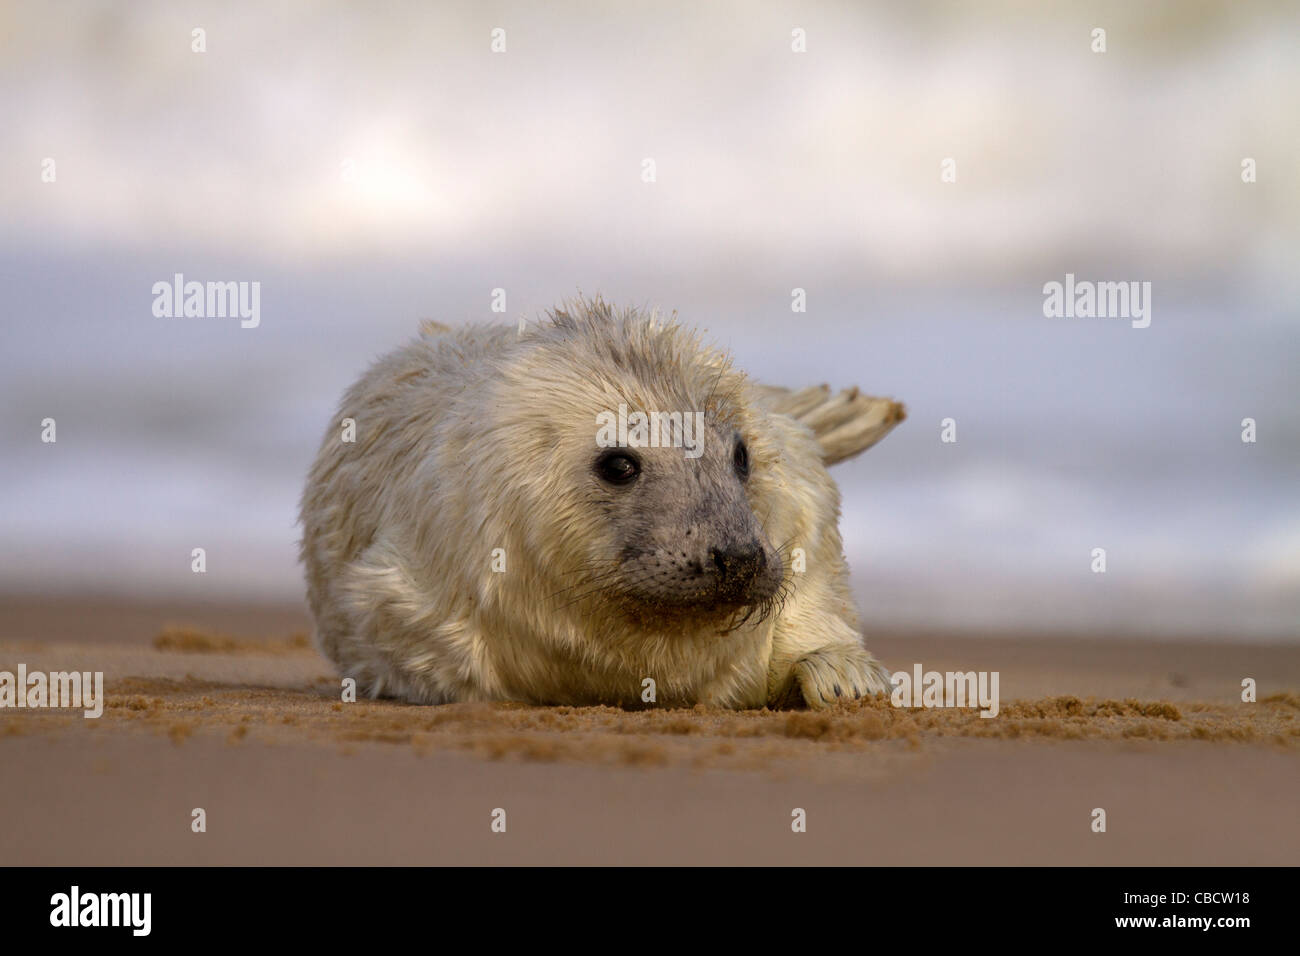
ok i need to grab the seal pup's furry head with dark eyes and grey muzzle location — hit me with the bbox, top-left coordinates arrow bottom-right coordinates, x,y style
467,300 -> 787,632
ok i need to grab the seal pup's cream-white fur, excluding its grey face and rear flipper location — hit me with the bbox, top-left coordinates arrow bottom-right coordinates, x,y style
302,302 -> 888,708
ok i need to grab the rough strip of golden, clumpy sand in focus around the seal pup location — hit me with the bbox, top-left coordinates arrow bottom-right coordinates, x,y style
0,627 -> 1300,770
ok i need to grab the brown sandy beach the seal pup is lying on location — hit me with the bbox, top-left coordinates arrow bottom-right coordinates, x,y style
0,597 -> 1300,865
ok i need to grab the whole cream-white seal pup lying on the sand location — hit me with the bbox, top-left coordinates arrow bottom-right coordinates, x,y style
300,299 -> 904,708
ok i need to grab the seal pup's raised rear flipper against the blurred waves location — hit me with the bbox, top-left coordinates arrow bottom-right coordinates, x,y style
758,385 -> 907,466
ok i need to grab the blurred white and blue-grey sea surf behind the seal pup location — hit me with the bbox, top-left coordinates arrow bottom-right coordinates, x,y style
0,3 -> 1300,641
